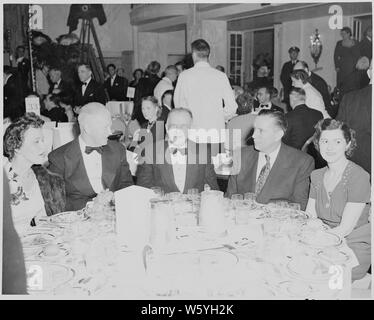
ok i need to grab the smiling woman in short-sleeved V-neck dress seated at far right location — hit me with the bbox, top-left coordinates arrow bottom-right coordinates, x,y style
306,119 -> 371,280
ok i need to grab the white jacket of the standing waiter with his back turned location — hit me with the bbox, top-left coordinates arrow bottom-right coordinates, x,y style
174,61 -> 238,143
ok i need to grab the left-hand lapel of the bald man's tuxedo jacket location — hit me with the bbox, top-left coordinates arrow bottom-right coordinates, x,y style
65,139 -> 95,195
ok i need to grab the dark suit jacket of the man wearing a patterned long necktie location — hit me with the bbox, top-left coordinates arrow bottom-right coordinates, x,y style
227,143 -> 314,210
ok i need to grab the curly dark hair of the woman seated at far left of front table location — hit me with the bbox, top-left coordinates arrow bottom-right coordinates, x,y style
4,112 -> 44,160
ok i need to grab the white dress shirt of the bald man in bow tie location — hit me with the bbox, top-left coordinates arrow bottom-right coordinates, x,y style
79,136 -> 104,193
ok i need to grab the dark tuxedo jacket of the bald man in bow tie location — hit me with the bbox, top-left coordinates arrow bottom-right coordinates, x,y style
48,138 -> 133,211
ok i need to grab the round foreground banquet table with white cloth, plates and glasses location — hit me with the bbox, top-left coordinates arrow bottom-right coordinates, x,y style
21,199 -> 357,299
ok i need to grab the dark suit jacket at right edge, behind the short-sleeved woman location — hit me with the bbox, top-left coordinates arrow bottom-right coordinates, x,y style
336,85 -> 372,173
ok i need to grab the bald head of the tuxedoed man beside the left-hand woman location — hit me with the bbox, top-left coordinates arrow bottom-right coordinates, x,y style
78,102 -> 112,147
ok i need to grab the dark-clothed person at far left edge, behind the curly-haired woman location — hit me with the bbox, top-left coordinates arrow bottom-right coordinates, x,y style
3,66 -> 25,119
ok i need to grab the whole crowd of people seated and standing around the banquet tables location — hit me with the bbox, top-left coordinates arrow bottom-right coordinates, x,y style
4,25 -> 371,292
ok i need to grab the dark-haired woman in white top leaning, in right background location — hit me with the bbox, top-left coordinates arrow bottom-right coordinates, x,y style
291,70 -> 330,119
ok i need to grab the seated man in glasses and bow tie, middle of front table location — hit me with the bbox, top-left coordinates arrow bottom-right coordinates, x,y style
137,108 -> 218,193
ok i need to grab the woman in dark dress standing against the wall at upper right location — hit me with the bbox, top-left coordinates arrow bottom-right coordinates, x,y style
334,27 -> 361,94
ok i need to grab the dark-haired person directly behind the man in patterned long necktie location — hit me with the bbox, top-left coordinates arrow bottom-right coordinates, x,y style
225,92 -> 256,150
